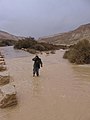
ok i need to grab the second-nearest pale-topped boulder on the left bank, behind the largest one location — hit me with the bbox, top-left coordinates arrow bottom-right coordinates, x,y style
0,71 -> 10,85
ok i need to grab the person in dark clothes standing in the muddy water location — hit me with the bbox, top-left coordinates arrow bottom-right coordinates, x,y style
32,55 -> 42,77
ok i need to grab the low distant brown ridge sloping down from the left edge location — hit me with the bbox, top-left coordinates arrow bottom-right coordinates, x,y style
0,30 -> 24,40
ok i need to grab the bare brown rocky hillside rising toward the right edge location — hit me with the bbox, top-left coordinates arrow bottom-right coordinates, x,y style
39,23 -> 90,45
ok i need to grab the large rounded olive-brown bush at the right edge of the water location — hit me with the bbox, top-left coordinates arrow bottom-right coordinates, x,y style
63,40 -> 90,64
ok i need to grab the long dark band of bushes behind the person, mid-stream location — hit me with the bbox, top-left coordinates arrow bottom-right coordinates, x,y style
14,38 -> 60,51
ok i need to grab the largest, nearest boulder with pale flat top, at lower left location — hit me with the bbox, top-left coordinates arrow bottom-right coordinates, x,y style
0,84 -> 17,108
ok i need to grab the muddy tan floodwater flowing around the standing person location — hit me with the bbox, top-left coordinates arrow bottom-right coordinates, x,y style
0,47 -> 90,120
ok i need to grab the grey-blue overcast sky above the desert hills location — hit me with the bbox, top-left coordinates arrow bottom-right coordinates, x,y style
0,0 -> 90,38
